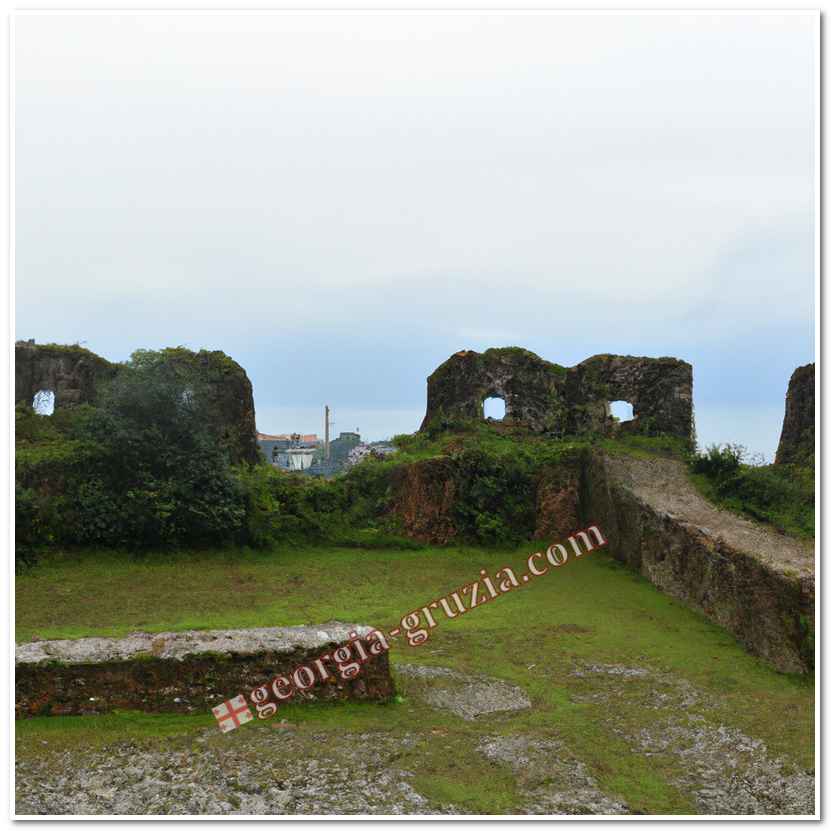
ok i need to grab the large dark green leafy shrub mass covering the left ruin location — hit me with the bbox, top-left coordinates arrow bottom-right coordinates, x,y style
16,352 -> 245,548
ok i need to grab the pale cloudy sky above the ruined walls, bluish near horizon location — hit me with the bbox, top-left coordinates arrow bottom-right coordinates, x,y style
14,12 -> 819,461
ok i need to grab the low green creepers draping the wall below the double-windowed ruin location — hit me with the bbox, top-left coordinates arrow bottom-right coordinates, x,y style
231,424 -> 586,547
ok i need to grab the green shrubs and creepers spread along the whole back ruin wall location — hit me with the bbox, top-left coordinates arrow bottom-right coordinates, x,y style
16,349 -> 813,565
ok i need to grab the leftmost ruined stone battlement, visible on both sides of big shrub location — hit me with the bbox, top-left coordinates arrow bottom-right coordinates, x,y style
14,341 -> 261,464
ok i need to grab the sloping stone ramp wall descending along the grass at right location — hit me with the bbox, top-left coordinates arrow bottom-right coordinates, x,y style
587,451 -> 814,673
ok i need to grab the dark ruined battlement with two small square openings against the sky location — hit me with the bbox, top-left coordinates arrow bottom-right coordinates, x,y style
421,347 -> 693,446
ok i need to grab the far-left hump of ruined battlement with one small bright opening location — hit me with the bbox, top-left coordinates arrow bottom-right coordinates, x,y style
14,341 -> 118,409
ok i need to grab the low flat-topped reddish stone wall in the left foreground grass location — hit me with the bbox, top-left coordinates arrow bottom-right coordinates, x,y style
15,623 -> 395,718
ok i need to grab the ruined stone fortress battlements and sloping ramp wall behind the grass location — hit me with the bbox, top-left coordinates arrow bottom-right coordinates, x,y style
15,341 -> 815,672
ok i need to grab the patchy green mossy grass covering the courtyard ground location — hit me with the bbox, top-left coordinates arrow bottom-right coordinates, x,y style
16,547 -> 814,813
